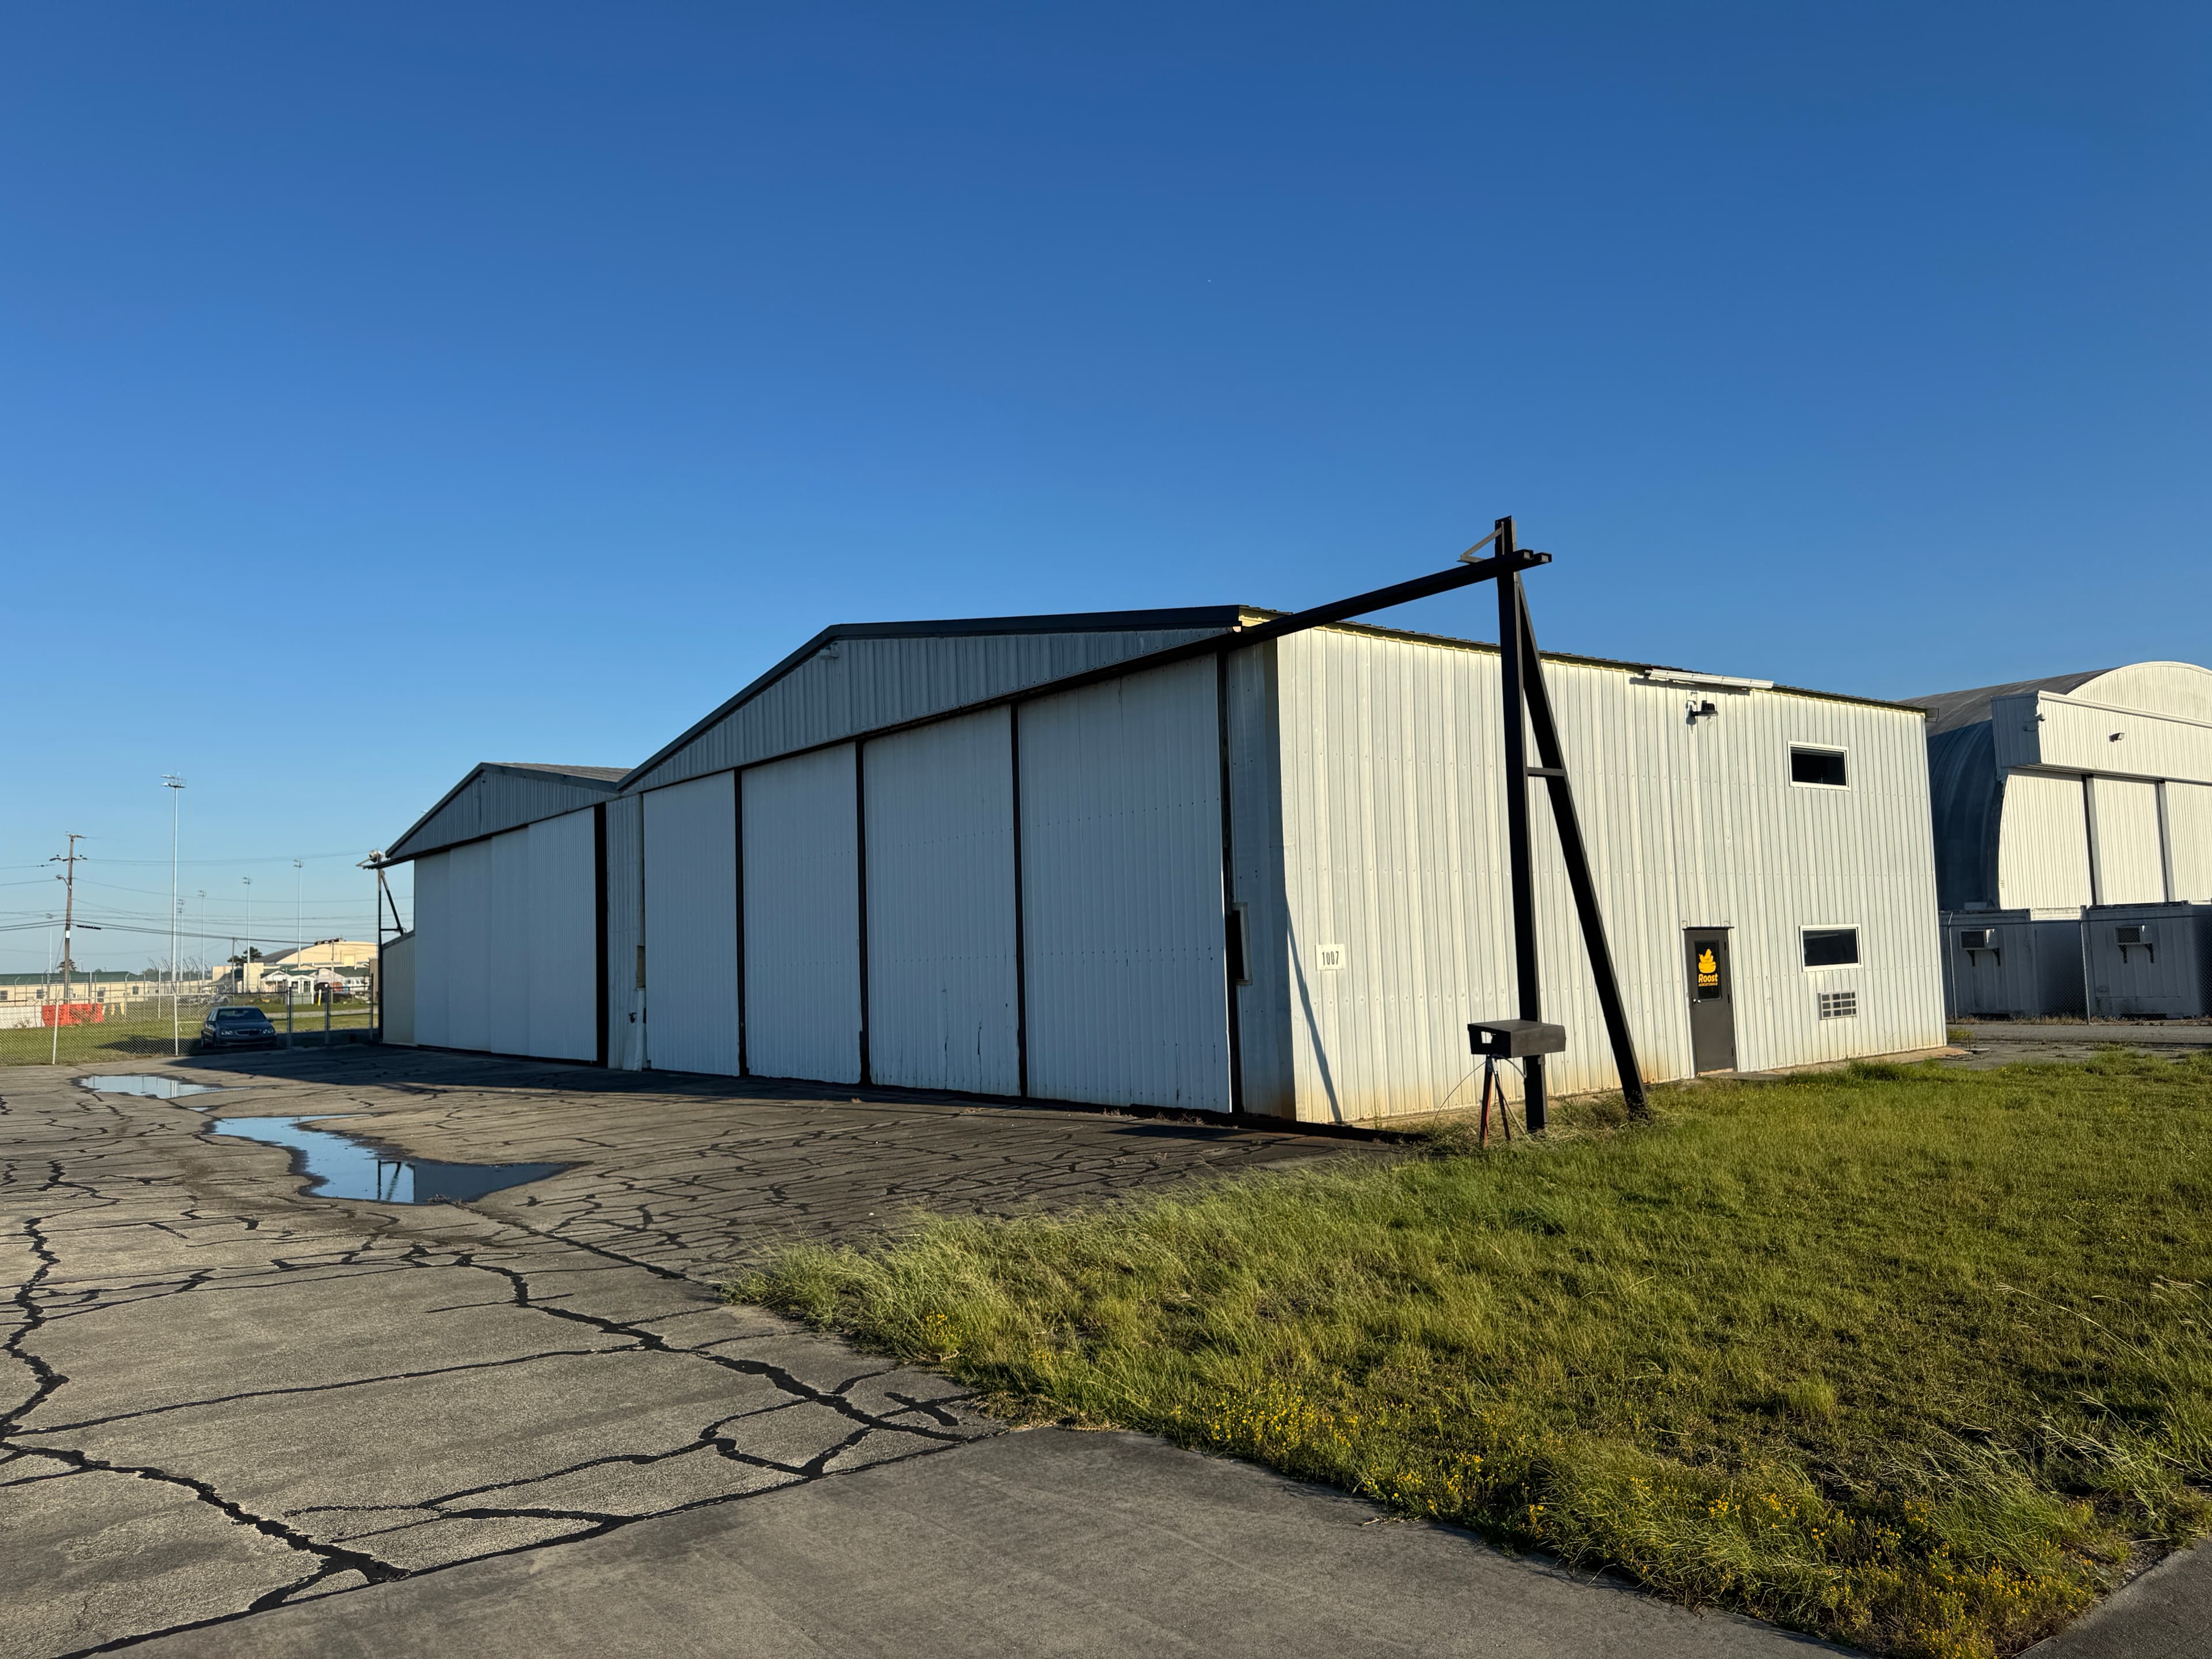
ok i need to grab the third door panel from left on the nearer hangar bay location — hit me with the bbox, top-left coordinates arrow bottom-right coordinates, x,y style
862,708 -> 1020,1095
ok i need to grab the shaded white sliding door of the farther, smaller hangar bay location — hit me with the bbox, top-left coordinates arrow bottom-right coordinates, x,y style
414,808 -> 601,1059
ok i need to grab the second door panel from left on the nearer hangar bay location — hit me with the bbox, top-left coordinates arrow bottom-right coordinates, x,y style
734,745 -> 861,1084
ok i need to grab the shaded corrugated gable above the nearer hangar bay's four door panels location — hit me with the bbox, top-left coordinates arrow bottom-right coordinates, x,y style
630,628 -> 1219,790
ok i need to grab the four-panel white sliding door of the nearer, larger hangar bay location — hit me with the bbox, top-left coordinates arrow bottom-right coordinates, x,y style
643,661 -> 1232,1111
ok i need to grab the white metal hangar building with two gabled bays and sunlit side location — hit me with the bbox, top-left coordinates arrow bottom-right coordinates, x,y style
387,606 -> 1944,1122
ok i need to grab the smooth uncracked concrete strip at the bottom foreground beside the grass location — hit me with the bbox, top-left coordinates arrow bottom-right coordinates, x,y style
129,1429 -> 1838,1659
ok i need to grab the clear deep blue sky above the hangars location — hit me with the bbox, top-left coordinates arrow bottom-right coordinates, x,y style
0,0 -> 2212,969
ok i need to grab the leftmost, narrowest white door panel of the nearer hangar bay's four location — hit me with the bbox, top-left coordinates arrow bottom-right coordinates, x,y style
646,772 -> 737,1075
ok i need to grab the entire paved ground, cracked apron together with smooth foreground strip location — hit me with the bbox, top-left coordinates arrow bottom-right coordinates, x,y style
0,1046 -> 1884,1659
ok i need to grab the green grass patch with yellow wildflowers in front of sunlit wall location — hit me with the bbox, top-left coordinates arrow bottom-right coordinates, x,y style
732,1053 -> 2212,1654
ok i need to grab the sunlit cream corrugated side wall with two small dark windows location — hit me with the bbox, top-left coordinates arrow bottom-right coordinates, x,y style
1277,628 -> 1942,1119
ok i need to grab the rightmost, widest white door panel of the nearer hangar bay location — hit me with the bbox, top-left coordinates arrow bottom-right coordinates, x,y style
1022,659 -> 1230,1111
